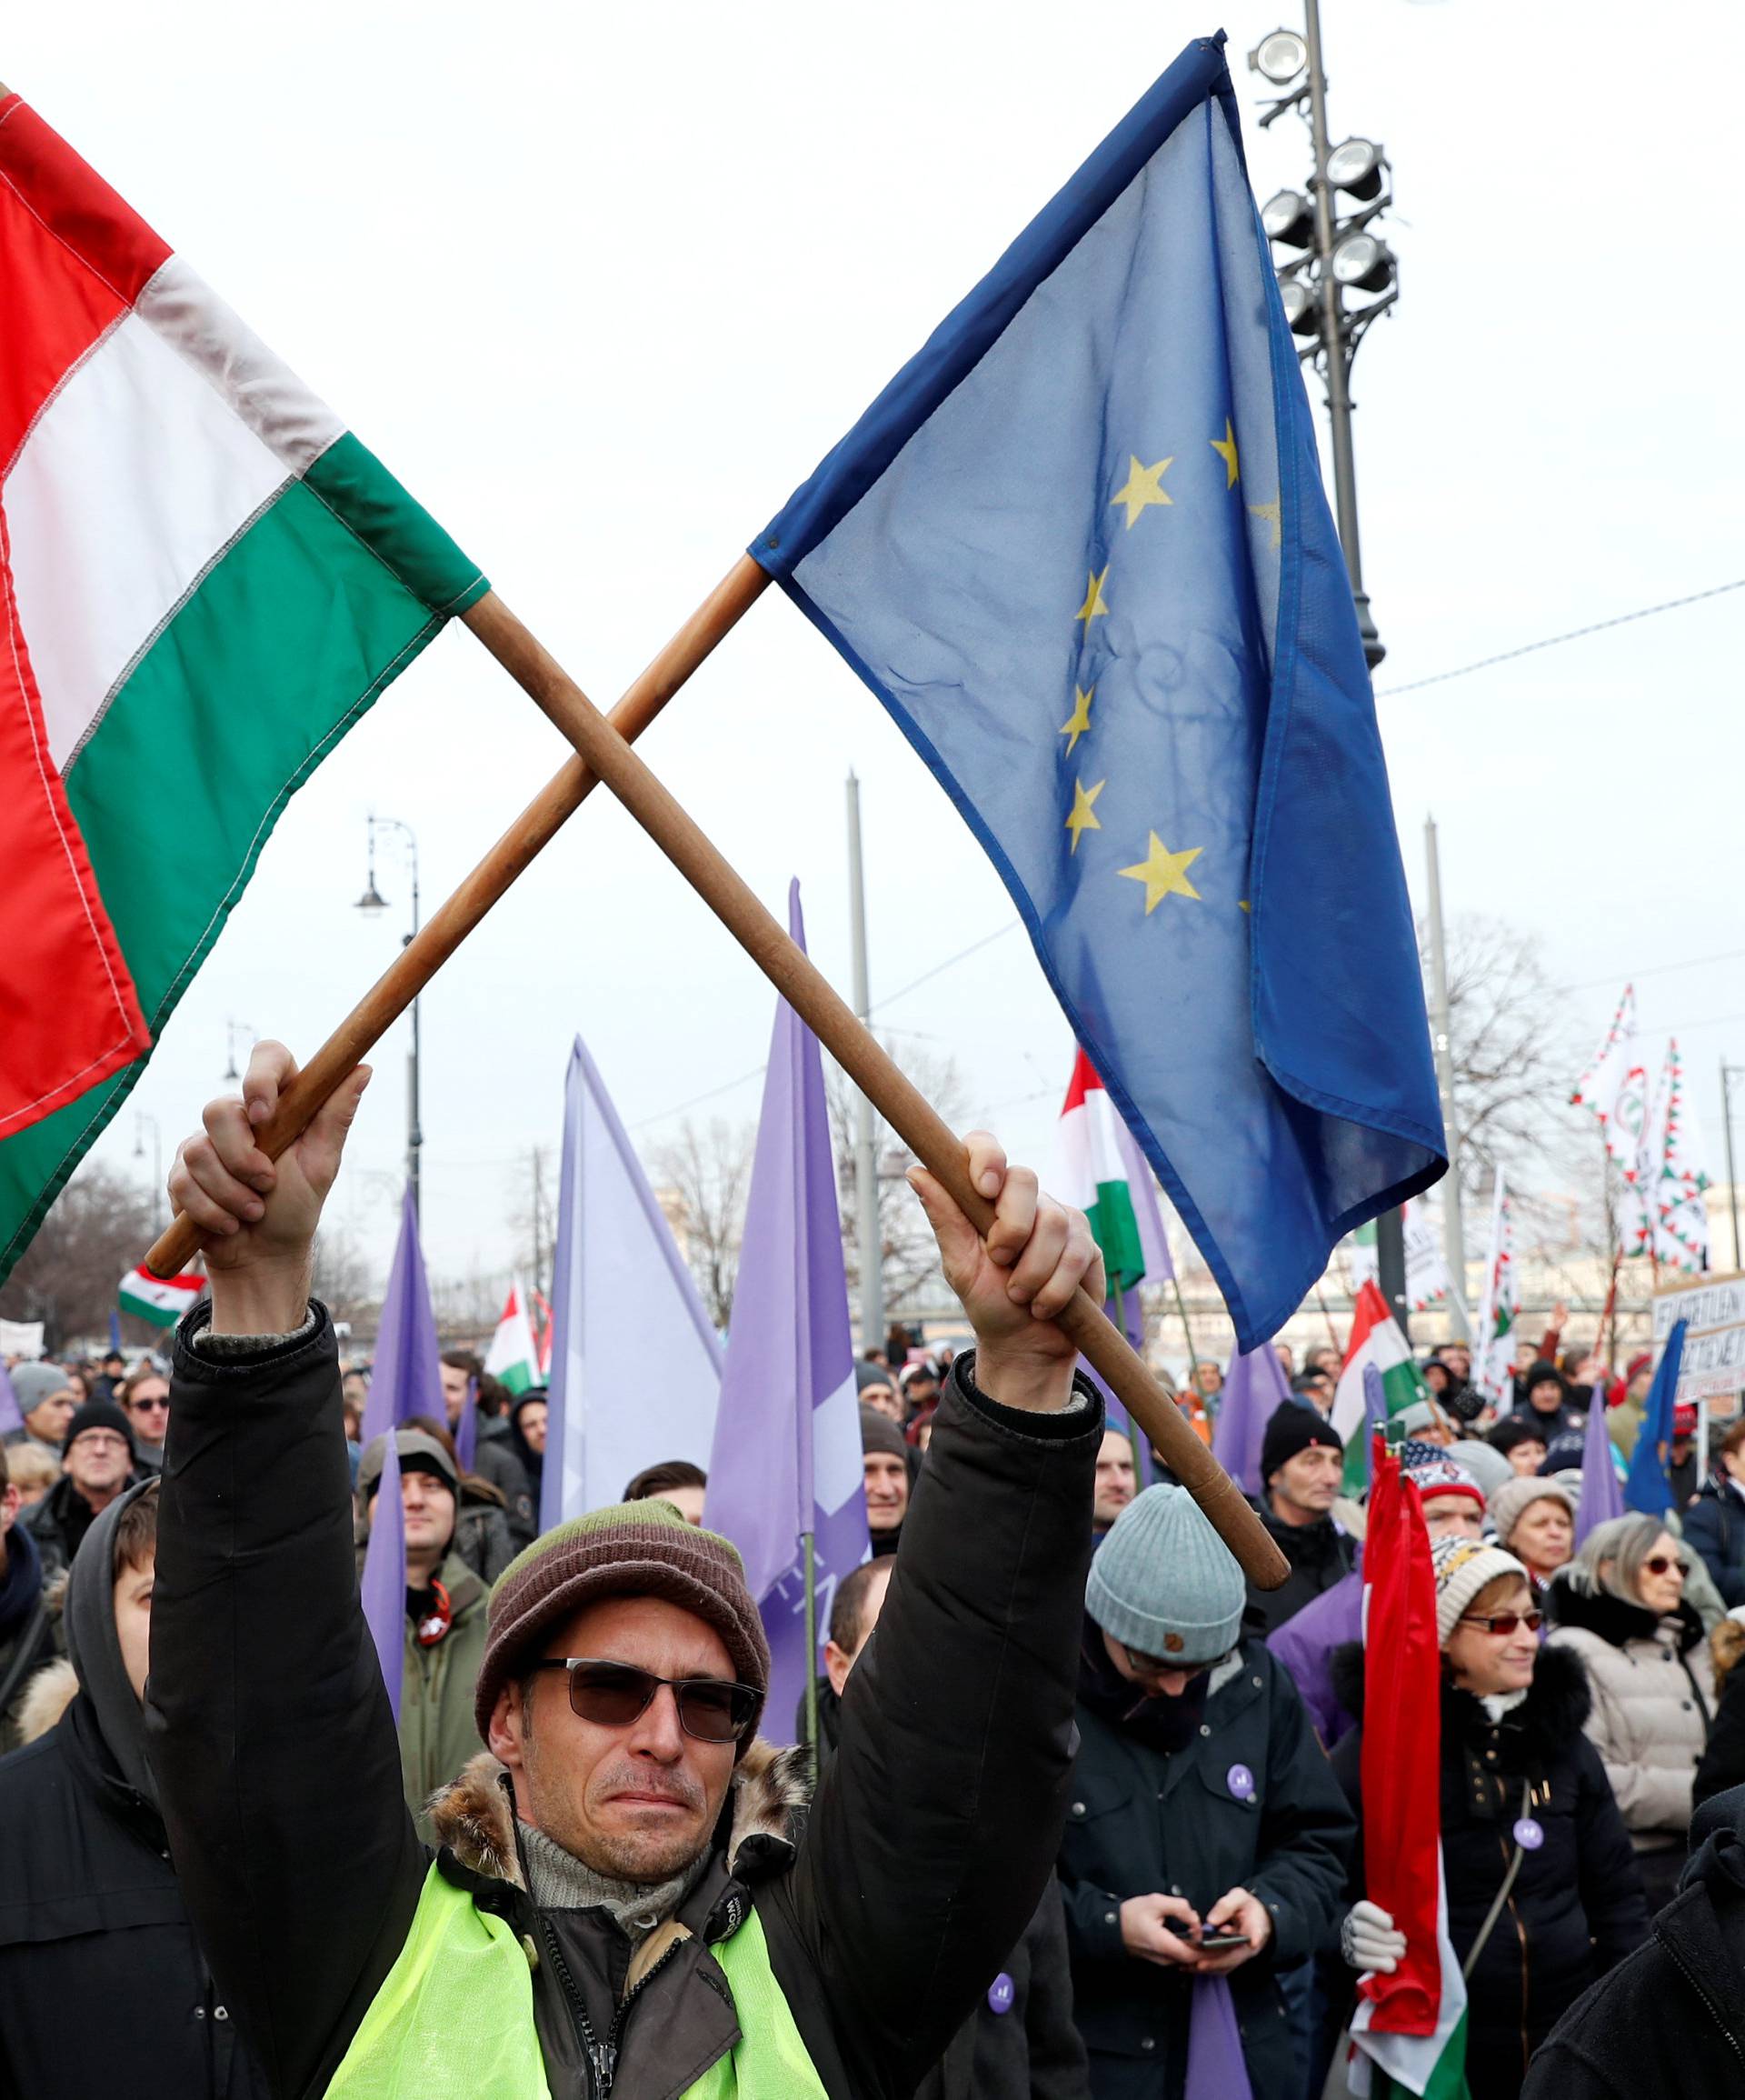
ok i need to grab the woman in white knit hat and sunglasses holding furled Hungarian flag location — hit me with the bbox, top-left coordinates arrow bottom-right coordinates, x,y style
1333,1539 -> 1649,2100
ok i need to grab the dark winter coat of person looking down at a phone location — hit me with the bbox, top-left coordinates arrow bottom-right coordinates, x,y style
1061,1640 -> 1357,2100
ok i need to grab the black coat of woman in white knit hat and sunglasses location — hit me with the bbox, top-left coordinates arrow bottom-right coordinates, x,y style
1333,1648 -> 1649,2100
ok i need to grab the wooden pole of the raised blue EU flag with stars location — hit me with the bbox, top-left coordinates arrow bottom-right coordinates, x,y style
145,555 -> 769,1276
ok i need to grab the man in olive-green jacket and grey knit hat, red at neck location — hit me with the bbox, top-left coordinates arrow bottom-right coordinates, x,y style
357,1428 -> 487,1835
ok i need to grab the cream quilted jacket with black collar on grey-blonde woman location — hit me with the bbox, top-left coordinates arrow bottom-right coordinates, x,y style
1546,1569 -> 1716,1852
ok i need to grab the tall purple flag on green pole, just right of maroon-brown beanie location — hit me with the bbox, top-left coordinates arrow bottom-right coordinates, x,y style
703,882 -> 867,1743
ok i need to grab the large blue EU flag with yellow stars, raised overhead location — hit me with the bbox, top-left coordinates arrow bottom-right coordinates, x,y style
752,35 -> 1447,1348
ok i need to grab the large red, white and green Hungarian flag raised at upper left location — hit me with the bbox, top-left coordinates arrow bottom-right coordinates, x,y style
0,95 -> 487,1279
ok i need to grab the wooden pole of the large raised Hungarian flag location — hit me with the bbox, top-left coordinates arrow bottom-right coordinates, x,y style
466,596 -> 1290,1590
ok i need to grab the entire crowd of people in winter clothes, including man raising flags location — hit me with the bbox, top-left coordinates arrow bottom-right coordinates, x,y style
0,1066 -> 1745,2100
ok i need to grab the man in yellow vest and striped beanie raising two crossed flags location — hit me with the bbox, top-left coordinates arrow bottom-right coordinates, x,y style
147,1044 -> 1104,2100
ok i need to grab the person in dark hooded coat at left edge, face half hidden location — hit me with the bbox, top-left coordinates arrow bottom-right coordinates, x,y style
0,1478 -> 271,2100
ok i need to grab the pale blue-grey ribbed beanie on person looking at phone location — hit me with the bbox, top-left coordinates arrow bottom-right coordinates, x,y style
1083,1486 -> 1247,1669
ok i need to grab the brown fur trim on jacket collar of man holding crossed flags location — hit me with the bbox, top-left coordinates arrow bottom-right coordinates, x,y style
426,1736 -> 813,1890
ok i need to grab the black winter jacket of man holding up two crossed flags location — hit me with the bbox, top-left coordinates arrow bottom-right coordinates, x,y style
147,1306 -> 1102,2100
